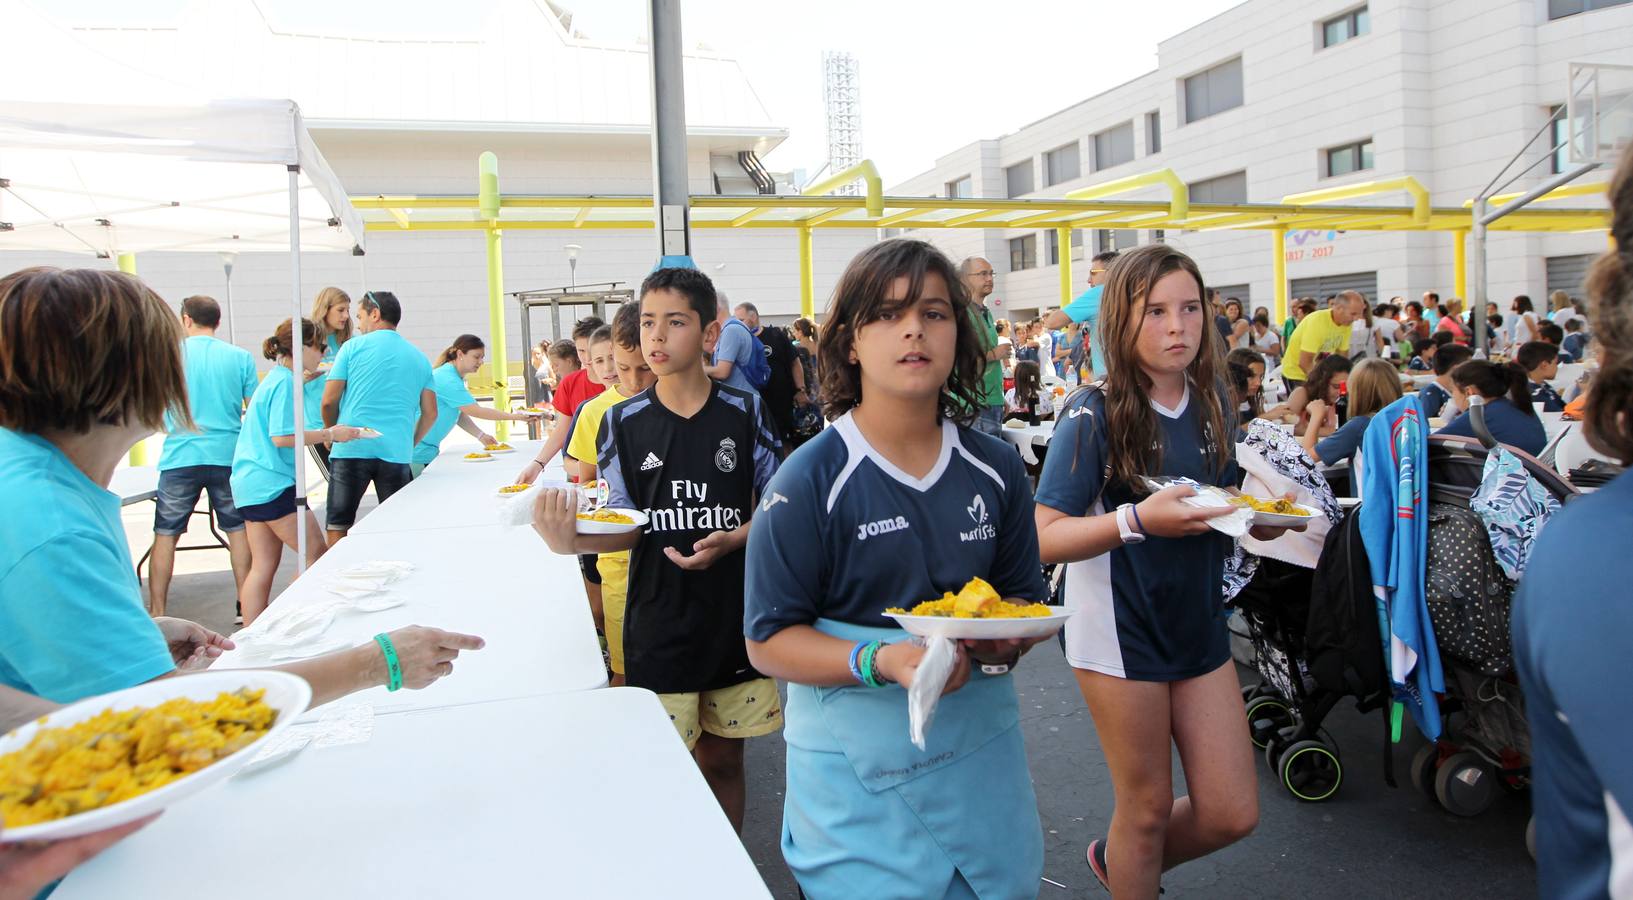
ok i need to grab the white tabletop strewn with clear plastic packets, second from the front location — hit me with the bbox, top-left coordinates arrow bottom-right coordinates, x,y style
216,525 -> 606,709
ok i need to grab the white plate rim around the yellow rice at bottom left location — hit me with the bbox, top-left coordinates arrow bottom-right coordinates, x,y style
0,670 -> 312,843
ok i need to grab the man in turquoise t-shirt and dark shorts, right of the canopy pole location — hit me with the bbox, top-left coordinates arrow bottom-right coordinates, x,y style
323,291 -> 436,542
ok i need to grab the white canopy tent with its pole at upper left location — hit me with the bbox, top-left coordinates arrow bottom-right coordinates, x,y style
0,100 -> 364,572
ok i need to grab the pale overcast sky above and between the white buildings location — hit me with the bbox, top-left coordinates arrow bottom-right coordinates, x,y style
54,0 -> 1239,185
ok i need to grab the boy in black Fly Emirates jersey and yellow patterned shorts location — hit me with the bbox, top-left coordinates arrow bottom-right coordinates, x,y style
534,268 -> 782,831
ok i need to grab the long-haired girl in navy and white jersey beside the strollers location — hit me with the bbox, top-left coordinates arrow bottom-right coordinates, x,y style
1037,243 -> 1280,897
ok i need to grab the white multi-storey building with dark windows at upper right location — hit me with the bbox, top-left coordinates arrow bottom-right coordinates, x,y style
887,0 -> 1633,317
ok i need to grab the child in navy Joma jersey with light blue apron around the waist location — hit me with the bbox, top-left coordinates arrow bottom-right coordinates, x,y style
745,240 -> 1047,898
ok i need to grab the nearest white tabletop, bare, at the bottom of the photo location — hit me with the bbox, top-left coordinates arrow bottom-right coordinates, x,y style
54,686 -> 769,900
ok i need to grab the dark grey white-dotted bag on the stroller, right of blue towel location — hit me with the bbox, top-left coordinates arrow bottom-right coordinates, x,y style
1424,500 -> 1514,676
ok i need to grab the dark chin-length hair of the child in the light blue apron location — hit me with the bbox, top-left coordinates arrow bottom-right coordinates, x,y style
817,238 -> 986,425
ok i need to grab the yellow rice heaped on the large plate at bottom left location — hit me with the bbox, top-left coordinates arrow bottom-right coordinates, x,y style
0,689 -> 278,828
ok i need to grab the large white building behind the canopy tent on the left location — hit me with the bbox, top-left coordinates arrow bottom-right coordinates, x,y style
0,0 -> 875,368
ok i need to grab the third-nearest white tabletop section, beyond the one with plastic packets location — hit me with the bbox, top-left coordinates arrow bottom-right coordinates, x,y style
351,441 -> 565,535
